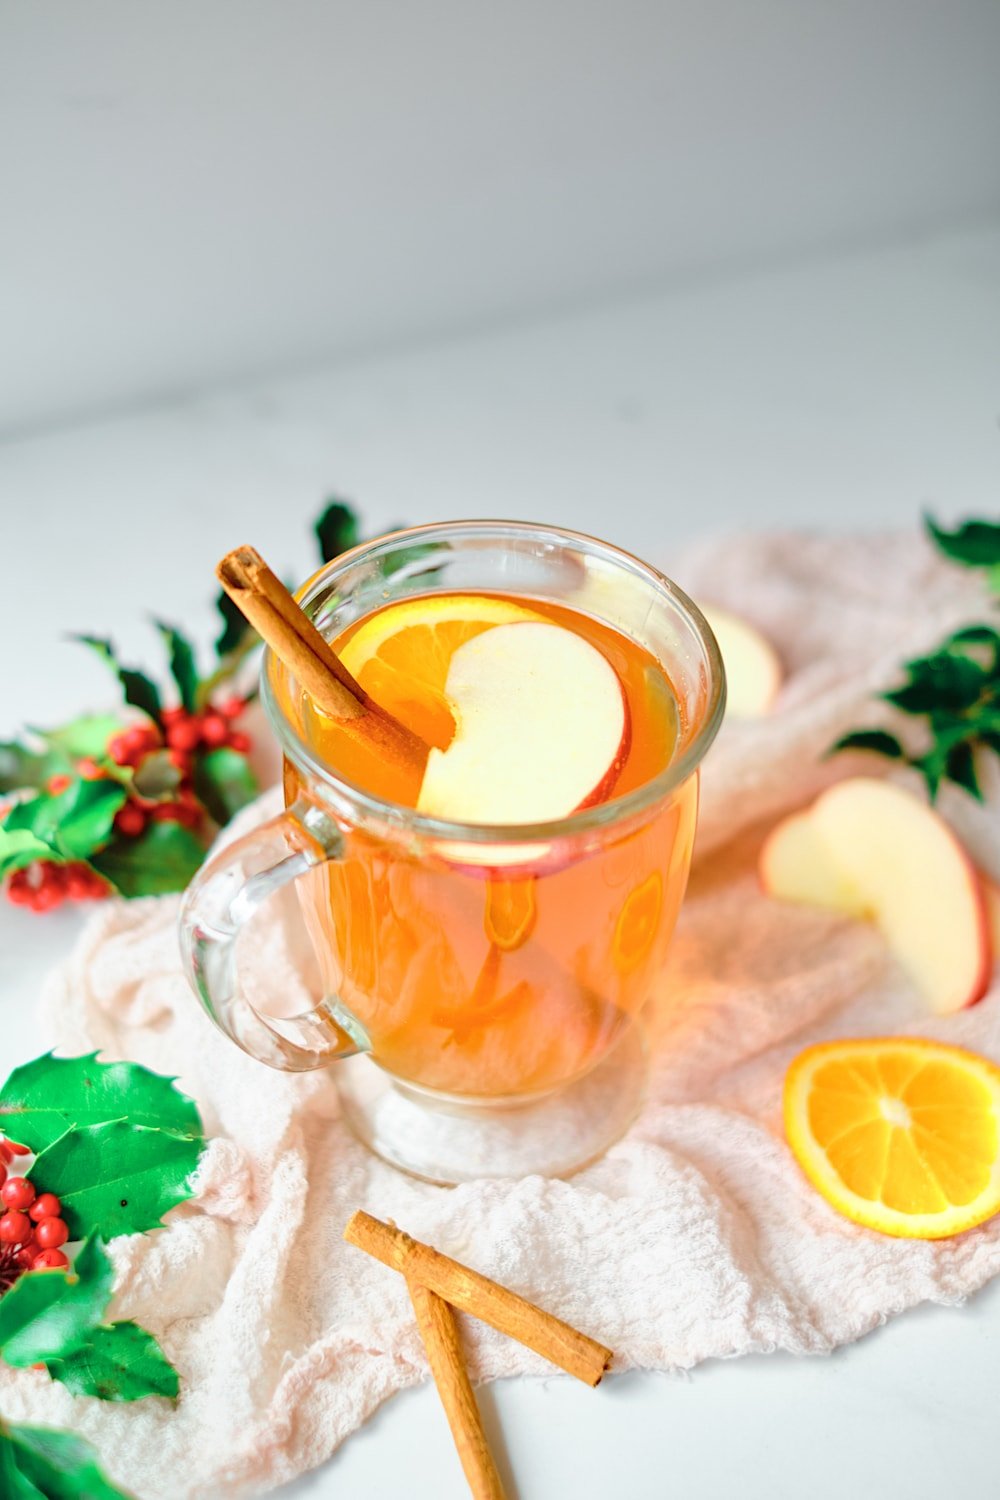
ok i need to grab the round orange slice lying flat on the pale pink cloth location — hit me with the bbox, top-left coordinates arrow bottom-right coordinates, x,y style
784,1037 -> 1000,1239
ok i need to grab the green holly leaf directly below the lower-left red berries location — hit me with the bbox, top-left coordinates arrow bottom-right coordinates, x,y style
0,1238 -> 114,1368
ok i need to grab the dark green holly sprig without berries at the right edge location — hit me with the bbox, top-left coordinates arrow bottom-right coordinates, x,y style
832,516 -> 1000,801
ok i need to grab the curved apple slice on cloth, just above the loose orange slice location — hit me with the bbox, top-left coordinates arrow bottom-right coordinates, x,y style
760,777 -> 991,1016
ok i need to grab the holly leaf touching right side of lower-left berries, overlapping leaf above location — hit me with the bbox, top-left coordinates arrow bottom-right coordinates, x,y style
31,1119 -> 204,1236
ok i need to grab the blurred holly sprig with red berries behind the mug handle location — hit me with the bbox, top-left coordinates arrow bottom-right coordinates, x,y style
0,500 -> 360,911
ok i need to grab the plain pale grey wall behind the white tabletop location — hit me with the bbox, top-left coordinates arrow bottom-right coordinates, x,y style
0,0 -> 1000,431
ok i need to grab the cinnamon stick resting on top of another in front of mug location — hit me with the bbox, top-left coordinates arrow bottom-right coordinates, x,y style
343,1209 -> 615,1386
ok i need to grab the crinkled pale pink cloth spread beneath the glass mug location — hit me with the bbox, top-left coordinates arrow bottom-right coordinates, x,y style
0,536 -> 1000,1500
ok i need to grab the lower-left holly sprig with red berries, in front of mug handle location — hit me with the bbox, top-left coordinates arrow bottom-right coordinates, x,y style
0,1053 -> 205,1410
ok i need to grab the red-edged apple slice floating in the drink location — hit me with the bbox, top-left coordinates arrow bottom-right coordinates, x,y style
417,621 -> 630,825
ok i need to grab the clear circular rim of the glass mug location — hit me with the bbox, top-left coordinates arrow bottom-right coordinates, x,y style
261,521 -> 726,845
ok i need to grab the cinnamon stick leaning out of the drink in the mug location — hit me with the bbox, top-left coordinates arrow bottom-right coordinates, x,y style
216,548 -> 427,761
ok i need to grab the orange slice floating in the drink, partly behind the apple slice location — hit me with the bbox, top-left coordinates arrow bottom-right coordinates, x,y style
337,594 -> 544,750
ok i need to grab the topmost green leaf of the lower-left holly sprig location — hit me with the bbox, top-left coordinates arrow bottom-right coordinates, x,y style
0,1052 -> 204,1154
